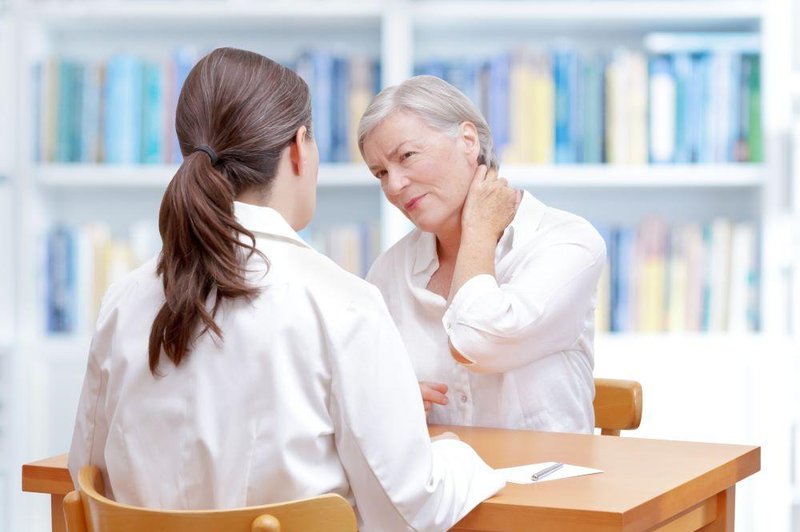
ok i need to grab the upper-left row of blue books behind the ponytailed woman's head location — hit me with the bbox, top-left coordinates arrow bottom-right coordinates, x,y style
33,47 -> 380,164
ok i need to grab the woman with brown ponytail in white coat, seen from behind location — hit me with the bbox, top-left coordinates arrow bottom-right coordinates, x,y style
69,48 -> 504,530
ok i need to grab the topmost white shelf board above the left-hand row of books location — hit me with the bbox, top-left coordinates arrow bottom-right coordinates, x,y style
33,0 -> 383,31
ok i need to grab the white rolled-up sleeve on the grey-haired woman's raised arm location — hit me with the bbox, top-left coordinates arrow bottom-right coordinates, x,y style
442,233 -> 606,373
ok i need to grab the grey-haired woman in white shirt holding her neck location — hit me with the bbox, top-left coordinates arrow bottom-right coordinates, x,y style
358,76 -> 605,432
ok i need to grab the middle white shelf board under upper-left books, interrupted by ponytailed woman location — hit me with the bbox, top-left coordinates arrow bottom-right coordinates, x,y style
34,163 -> 377,190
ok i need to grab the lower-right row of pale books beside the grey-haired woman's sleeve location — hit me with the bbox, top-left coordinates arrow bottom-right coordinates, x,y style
596,218 -> 760,332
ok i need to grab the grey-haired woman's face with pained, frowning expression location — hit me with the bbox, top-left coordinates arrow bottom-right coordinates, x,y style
364,111 -> 480,234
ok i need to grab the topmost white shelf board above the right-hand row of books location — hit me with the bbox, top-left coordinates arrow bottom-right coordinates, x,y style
413,0 -> 762,30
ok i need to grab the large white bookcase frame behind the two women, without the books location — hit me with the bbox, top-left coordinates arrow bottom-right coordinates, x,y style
6,0 -> 800,531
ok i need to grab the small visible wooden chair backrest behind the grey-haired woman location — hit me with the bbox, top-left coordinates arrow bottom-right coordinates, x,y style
594,379 -> 642,436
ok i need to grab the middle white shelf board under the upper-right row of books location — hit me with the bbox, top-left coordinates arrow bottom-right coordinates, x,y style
500,164 -> 765,188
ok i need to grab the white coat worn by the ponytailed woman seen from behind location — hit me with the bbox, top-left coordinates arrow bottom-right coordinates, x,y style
69,203 -> 504,531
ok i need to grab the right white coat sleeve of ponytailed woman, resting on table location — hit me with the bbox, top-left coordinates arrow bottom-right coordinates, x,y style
331,288 -> 505,531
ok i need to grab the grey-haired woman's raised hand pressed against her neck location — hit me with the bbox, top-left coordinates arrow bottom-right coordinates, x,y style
461,165 -> 522,243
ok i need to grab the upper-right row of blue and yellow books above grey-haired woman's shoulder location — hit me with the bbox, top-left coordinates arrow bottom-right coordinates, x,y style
415,33 -> 763,164
